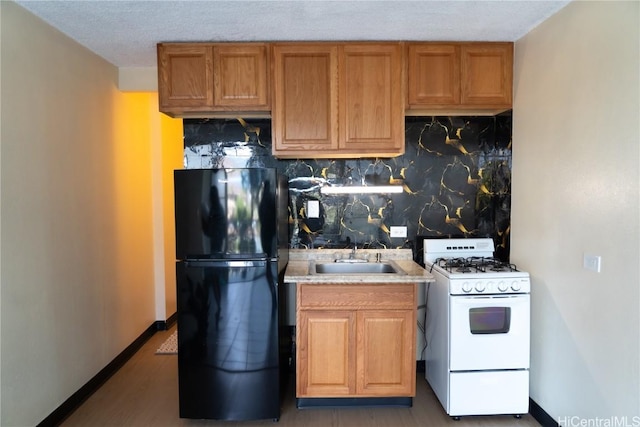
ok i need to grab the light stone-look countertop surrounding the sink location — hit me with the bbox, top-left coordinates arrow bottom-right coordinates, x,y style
284,249 -> 434,284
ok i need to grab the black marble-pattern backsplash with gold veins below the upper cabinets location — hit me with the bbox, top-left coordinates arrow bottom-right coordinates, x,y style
184,113 -> 511,260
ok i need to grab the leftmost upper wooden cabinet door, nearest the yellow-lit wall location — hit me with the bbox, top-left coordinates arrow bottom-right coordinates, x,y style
158,44 -> 213,112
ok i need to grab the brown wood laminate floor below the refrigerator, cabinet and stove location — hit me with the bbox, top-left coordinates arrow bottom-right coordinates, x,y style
61,325 -> 540,427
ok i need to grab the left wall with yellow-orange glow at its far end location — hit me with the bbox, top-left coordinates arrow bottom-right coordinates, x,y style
0,1 -> 175,426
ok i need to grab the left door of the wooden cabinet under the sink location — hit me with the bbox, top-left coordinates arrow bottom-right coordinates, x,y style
296,310 -> 356,397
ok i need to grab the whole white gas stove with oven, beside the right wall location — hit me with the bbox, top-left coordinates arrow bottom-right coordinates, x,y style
423,238 -> 531,418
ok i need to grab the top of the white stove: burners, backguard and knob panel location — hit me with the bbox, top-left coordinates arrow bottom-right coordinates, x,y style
424,238 -> 531,295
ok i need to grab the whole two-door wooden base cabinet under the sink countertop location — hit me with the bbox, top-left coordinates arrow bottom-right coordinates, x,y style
296,283 -> 416,398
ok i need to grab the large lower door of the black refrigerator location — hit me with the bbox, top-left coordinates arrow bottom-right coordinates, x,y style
177,262 -> 280,420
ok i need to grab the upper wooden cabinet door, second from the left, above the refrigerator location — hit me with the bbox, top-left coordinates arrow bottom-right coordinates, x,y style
213,43 -> 270,111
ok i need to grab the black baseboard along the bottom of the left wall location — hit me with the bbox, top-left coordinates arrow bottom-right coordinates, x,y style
37,313 -> 177,427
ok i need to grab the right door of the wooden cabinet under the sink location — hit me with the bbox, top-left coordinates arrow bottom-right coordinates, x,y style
356,310 -> 416,396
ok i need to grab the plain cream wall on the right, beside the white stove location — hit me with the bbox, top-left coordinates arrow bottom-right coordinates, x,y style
511,1 -> 640,425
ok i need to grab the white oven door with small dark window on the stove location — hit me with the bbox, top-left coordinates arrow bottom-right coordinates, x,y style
449,294 -> 530,371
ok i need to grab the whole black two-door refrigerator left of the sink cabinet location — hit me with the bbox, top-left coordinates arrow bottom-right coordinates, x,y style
174,168 -> 289,420
